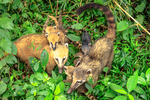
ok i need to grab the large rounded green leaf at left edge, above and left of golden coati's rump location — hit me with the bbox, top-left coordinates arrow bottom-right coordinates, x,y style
0,17 -> 14,30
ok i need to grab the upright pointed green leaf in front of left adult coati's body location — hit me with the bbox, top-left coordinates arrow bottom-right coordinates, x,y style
40,49 -> 49,70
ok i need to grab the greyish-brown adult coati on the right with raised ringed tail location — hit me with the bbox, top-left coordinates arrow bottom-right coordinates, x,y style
67,3 -> 116,93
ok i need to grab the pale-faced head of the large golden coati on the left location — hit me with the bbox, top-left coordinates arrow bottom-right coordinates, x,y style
52,43 -> 69,73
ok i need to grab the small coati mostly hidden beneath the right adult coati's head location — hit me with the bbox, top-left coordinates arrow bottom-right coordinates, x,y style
63,66 -> 96,100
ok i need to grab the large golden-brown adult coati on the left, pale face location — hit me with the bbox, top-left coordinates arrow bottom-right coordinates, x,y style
14,34 -> 68,75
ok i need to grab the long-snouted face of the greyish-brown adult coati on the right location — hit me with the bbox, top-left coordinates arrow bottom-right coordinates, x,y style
67,67 -> 92,93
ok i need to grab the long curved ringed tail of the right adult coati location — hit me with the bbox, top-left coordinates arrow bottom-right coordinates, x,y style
76,3 -> 116,40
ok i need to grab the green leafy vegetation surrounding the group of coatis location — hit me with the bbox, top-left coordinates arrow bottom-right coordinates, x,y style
0,0 -> 150,100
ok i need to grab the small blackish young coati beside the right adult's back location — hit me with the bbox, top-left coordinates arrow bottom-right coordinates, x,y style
81,31 -> 92,55
